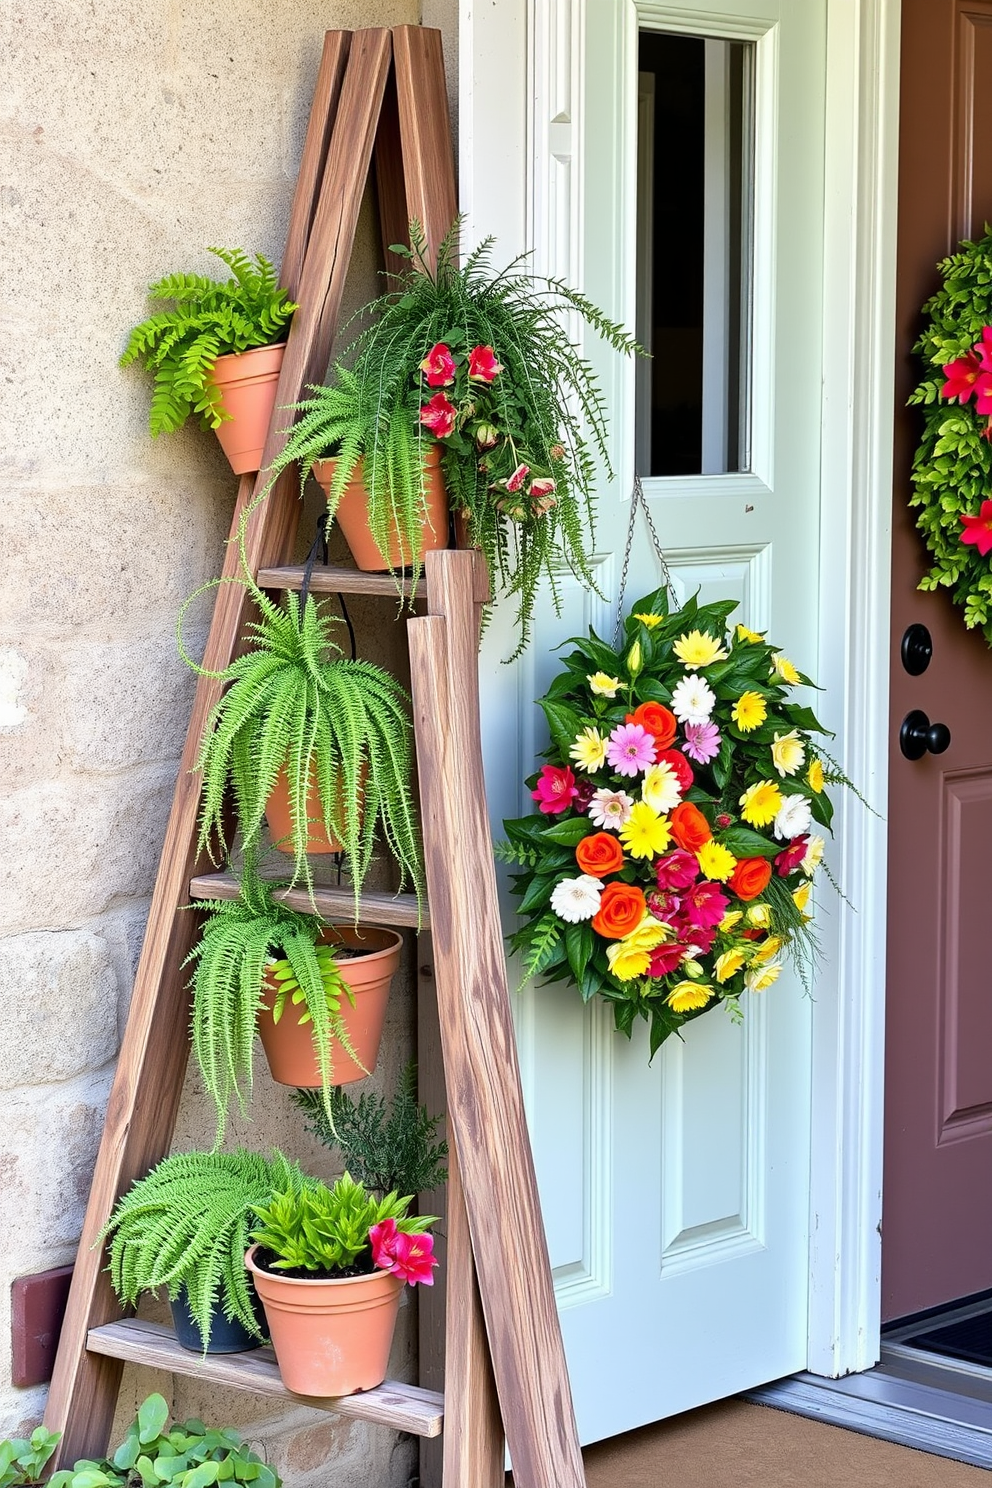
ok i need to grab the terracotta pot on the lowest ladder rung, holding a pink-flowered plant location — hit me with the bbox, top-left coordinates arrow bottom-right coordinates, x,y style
244,1245 -> 405,1396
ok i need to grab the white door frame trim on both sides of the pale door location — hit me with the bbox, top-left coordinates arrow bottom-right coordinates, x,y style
458,0 -> 900,1376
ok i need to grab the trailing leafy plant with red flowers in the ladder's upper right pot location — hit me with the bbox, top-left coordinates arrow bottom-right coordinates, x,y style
263,223 -> 638,655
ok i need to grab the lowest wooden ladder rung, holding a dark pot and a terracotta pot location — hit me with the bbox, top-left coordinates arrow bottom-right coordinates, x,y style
86,1318 -> 445,1436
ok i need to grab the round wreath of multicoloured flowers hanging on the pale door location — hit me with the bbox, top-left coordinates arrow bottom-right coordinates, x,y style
497,589 -> 848,1055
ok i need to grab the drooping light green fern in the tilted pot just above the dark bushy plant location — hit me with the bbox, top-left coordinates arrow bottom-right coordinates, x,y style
184,859 -> 355,1146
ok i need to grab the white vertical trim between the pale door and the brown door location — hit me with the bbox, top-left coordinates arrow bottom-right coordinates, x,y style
809,0 -> 900,1375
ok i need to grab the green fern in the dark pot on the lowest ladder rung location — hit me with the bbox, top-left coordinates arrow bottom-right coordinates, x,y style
101,1149 -> 305,1350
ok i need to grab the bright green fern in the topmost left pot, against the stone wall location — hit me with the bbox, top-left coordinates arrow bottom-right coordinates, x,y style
120,248 -> 297,434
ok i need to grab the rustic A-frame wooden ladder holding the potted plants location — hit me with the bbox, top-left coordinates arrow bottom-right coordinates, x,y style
46,27 -> 584,1488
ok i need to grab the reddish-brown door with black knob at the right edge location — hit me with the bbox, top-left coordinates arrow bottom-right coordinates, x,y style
882,0 -> 992,1318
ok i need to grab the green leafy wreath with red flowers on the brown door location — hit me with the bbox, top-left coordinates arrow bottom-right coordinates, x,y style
909,235 -> 992,646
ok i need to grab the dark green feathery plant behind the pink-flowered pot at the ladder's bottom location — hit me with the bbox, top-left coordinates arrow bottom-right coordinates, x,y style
292,1064 -> 448,1195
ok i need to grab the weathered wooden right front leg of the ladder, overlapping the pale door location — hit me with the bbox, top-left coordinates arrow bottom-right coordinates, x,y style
408,552 -> 584,1488
